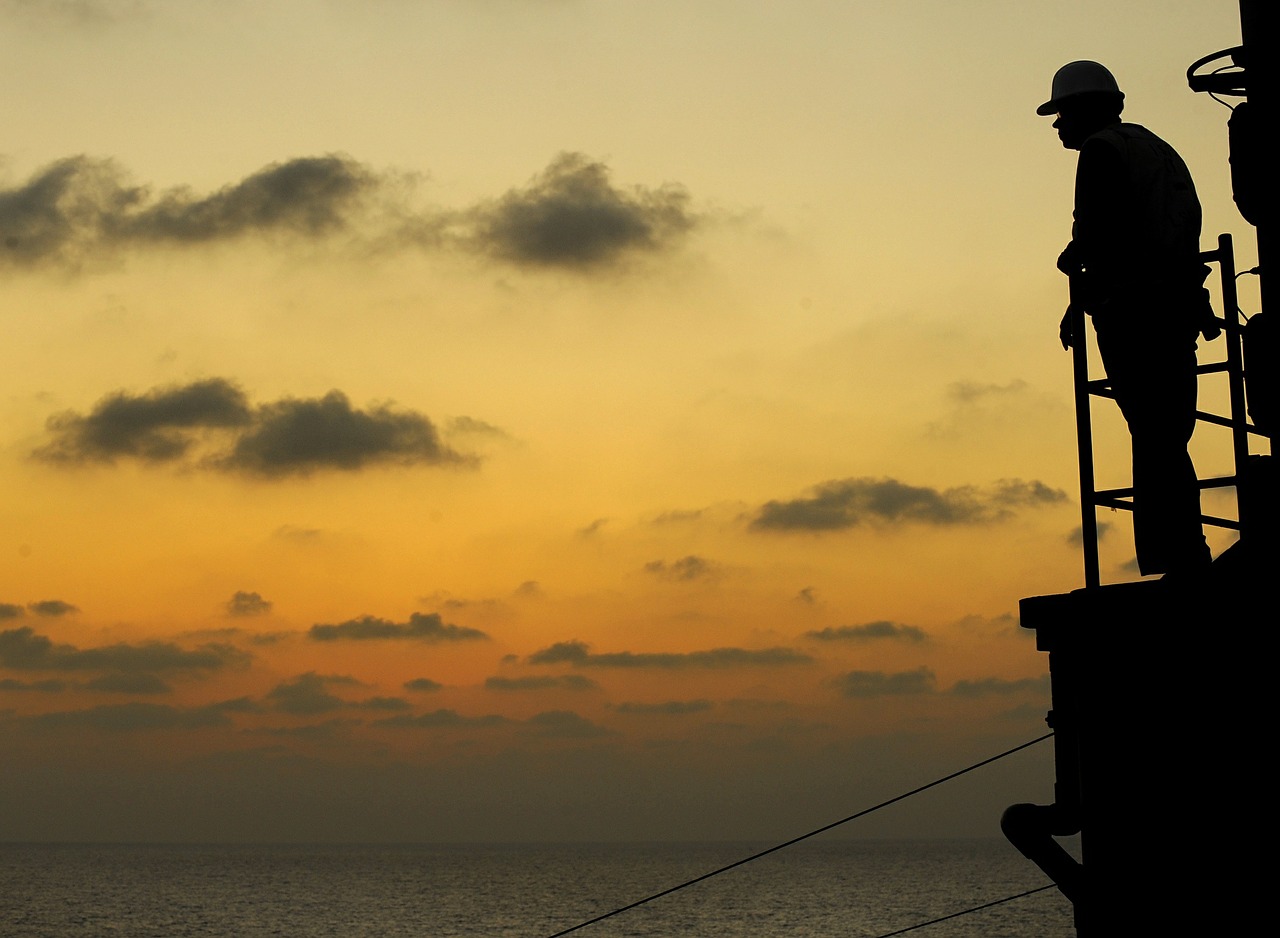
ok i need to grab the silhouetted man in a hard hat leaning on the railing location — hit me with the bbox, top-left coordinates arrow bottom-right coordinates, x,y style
1036,61 -> 1217,575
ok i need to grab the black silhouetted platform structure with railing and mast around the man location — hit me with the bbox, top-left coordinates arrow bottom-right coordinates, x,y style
1001,0 -> 1280,938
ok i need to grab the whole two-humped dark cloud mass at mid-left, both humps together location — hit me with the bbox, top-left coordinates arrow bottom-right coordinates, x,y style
32,378 -> 476,479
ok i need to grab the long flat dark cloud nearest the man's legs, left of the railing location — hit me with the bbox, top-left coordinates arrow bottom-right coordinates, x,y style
751,477 -> 1066,531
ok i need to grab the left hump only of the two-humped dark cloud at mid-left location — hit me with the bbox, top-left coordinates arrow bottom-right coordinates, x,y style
35,378 -> 252,465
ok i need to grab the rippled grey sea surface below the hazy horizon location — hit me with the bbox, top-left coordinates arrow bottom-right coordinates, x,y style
0,839 -> 1075,938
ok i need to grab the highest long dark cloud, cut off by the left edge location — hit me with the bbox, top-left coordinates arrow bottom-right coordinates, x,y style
0,155 -> 379,267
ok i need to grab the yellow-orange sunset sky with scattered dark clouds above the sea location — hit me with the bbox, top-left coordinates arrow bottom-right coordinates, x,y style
0,0 -> 1256,842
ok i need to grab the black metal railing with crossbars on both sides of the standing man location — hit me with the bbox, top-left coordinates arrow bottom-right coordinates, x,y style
1071,234 -> 1262,589
